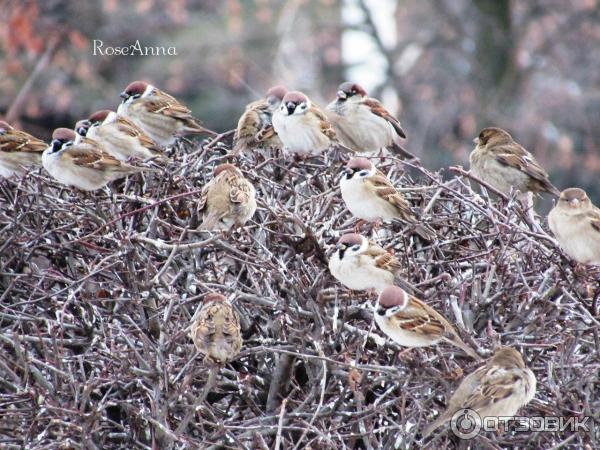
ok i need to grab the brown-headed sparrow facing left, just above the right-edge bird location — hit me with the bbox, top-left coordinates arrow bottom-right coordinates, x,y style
469,128 -> 559,196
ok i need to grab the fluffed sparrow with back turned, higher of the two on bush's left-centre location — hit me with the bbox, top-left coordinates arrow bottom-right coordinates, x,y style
198,164 -> 256,231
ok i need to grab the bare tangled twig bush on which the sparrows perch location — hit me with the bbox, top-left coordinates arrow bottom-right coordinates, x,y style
0,138 -> 600,449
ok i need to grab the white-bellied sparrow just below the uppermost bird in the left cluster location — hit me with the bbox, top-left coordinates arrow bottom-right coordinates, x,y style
81,109 -> 162,161
